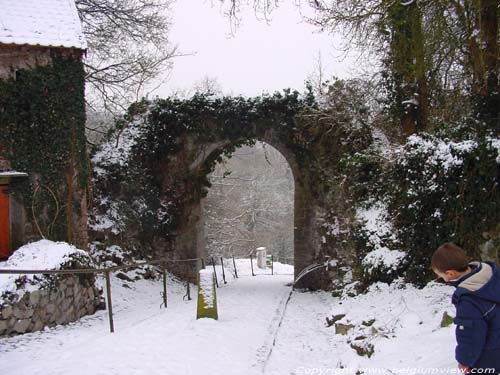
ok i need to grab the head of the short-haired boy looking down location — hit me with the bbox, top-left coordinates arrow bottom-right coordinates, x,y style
431,242 -> 469,281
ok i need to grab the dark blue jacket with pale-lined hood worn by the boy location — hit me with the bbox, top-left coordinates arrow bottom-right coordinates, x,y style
451,262 -> 500,374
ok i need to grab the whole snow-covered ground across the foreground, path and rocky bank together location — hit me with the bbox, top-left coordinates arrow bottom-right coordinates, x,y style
0,260 -> 455,375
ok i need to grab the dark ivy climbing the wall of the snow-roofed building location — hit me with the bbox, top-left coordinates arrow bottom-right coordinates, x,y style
0,50 -> 88,247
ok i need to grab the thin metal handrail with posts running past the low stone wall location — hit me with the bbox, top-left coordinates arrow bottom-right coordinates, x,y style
0,258 -> 203,333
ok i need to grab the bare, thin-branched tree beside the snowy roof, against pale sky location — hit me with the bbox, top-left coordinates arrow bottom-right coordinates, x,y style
75,0 -> 176,113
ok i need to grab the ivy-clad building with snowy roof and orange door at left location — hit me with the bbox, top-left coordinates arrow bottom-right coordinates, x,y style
0,0 -> 88,258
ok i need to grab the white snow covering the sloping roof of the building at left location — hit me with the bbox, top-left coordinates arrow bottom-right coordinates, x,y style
0,0 -> 87,49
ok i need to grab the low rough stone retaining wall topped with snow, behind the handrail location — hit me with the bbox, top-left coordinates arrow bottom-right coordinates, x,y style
0,275 -> 103,337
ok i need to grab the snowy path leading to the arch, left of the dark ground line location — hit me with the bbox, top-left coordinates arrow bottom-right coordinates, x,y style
0,275 -> 292,375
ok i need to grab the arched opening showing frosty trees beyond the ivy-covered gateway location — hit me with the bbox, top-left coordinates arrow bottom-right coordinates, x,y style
202,142 -> 295,265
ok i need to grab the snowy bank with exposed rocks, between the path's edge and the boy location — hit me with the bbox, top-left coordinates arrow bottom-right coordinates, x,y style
265,283 -> 456,375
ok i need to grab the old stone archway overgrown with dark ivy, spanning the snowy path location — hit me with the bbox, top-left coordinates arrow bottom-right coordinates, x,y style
94,91 -> 376,287
